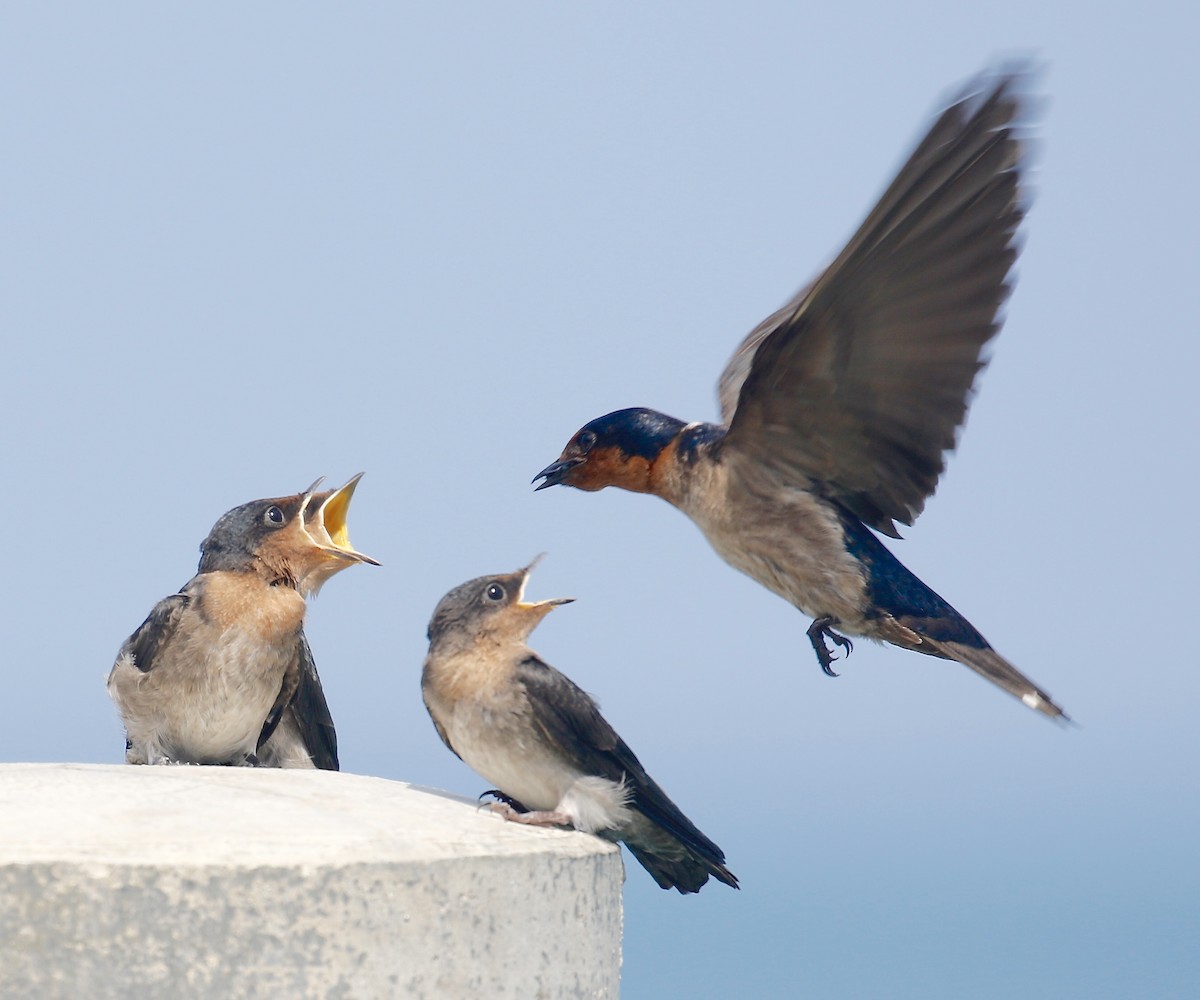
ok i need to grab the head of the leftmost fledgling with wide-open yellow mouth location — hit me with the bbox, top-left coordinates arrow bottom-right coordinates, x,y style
199,473 -> 379,594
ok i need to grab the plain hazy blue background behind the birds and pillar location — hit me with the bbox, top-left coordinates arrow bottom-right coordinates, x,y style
0,0 -> 1200,1000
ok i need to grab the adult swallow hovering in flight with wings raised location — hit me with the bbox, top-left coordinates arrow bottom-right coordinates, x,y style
533,68 -> 1067,720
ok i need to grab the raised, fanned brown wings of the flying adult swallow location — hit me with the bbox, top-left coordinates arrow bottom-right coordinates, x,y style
719,69 -> 1022,537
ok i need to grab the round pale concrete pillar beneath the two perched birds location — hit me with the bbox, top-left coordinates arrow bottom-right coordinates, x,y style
0,764 -> 623,1000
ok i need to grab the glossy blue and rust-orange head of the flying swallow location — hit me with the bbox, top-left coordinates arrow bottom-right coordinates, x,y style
533,407 -> 685,493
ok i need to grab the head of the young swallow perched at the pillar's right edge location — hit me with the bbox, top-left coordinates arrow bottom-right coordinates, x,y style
427,556 -> 575,647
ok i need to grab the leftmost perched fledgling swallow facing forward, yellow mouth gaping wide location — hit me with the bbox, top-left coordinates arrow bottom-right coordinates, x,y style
108,473 -> 378,771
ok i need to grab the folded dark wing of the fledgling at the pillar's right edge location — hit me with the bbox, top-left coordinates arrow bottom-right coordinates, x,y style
517,657 -> 725,862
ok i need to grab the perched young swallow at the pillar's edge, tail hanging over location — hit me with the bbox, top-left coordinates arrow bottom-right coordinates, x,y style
421,559 -> 738,893
